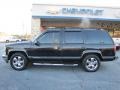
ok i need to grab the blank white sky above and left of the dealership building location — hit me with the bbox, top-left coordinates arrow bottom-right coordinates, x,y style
0,0 -> 120,34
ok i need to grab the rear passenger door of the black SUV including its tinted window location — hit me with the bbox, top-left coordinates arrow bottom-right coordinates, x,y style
61,31 -> 84,59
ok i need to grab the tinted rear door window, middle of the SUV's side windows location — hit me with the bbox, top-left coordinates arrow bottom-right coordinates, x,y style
65,31 -> 83,43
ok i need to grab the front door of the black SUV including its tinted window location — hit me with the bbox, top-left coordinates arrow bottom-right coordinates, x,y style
30,31 -> 60,59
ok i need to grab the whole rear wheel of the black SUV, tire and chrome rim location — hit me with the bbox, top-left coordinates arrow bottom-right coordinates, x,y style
82,54 -> 100,72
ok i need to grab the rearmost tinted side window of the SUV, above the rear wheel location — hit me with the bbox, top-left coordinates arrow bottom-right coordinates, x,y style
85,30 -> 113,44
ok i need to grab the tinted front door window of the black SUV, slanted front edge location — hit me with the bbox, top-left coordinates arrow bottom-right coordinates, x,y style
38,32 -> 60,43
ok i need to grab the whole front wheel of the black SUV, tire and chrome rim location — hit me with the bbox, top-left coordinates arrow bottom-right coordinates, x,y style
10,53 -> 28,71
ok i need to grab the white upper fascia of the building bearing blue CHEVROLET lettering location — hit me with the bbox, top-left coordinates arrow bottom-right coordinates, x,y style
32,4 -> 120,21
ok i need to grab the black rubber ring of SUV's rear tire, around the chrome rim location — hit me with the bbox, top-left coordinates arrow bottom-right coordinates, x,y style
82,55 -> 100,72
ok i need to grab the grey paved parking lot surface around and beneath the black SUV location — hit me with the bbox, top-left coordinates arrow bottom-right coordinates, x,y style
0,43 -> 120,90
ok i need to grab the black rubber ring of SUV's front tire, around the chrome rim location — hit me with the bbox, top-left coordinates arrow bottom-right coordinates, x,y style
10,53 -> 28,71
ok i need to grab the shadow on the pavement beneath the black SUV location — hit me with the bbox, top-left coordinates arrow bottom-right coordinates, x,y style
27,62 -> 109,73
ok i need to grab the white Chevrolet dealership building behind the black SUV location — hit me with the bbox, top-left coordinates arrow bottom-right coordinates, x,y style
32,4 -> 120,35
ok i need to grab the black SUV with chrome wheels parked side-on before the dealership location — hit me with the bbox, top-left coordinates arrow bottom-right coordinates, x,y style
3,28 -> 115,72
